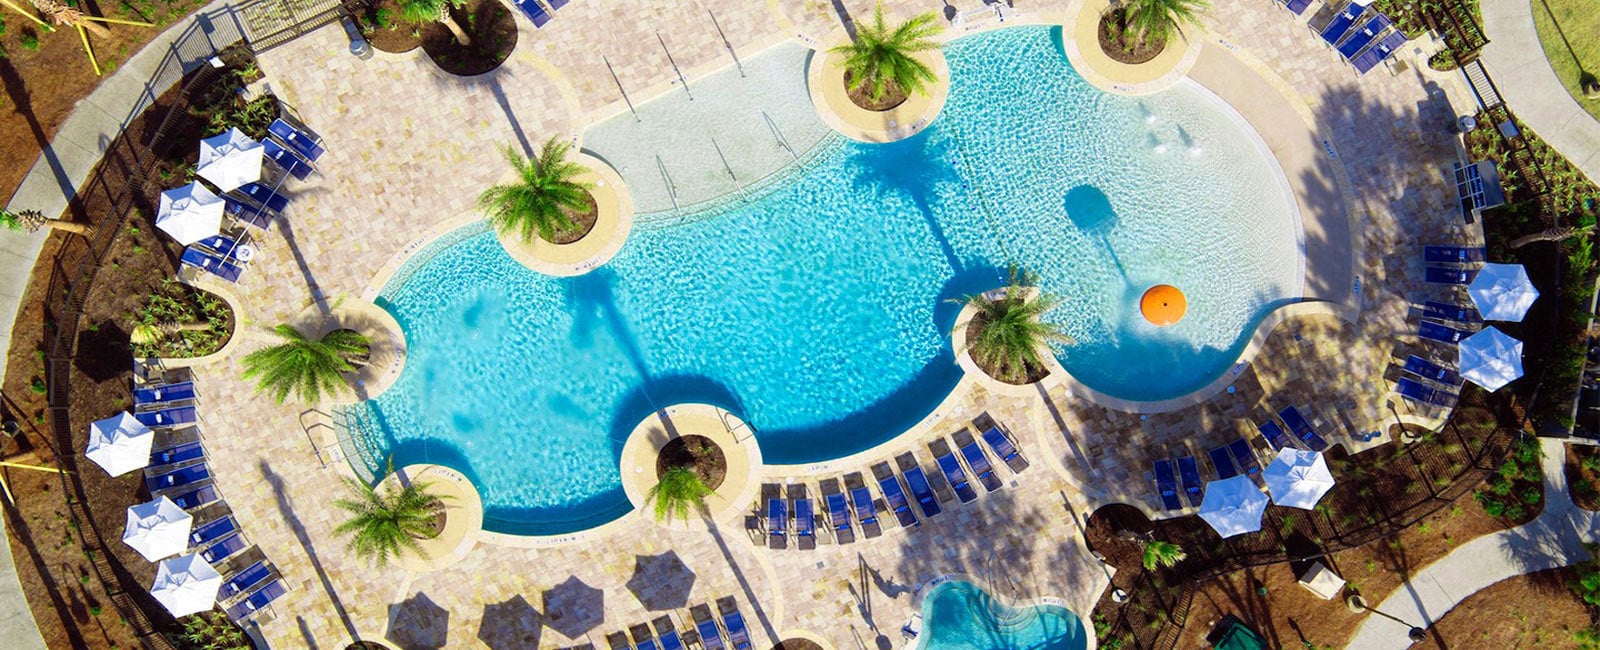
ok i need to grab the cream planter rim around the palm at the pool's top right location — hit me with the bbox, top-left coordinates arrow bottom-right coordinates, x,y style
1062,0 -> 1202,96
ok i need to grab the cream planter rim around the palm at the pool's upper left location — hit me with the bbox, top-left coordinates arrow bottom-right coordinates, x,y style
496,152 -> 634,277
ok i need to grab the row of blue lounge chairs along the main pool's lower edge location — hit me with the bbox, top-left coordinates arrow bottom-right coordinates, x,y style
758,419 -> 1027,549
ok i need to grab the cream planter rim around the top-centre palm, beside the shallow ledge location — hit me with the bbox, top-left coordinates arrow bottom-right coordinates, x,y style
806,29 -> 950,142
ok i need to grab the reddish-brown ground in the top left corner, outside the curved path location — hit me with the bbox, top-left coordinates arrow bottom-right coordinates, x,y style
0,0 -> 203,206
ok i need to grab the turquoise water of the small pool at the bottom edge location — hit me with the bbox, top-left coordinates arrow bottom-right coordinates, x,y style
917,580 -> 1088,650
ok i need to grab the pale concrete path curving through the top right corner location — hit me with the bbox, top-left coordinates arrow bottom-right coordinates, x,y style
1480,0 -> 1600,181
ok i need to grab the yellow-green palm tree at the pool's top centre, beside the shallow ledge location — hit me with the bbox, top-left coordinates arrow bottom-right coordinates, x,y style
829,3 -> 939,101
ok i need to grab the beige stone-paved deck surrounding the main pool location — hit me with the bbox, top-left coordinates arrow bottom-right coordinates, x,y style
159,0 -> 1482,648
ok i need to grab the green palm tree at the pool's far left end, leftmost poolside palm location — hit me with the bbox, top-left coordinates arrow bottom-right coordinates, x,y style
245,325 -> 371,403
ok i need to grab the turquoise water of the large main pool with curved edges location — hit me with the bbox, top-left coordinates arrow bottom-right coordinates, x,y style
365,27 -> 1299,535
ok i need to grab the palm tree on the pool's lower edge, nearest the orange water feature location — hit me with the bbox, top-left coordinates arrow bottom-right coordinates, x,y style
965,269 -> 1072,383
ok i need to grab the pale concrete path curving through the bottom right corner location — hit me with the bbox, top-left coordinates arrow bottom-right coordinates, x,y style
1349,435 -> 1600,650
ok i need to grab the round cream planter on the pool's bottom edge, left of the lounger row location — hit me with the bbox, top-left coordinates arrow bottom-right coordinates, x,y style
621,403 -> 762,530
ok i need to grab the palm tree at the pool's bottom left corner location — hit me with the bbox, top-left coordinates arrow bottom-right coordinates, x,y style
333,477 -> 445,567
